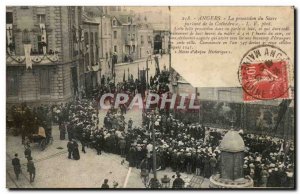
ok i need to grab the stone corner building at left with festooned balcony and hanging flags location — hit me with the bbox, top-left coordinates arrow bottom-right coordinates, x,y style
6,6 -> 82,104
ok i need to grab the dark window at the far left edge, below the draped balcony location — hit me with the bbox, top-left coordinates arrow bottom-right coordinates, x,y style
6,70 -> 19,96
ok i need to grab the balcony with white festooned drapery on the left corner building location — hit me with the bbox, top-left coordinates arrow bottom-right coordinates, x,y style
6,54 -> 59,66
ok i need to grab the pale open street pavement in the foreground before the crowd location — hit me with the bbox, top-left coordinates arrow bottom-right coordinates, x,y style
6,104 -> 208,188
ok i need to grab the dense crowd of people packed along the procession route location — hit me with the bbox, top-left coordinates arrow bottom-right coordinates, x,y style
9,68 -> 294,188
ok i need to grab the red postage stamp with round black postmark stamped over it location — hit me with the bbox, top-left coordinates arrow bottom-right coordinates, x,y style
238,45 -> 290,101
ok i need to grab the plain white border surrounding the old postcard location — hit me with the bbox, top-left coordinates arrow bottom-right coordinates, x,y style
0,0 -> 300,193
